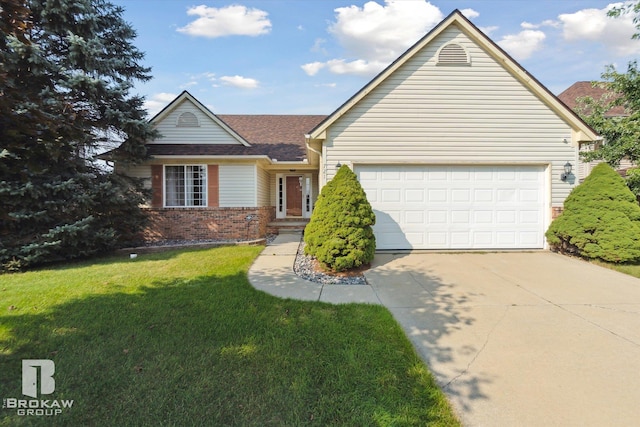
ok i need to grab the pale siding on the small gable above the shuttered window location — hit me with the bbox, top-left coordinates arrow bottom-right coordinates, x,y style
154,100 -> 240,144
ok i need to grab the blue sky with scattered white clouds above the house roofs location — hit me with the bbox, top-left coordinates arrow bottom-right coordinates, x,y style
112,0 -> 640,115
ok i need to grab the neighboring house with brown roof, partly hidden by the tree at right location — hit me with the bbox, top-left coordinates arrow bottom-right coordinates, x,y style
558,82 -> 634,179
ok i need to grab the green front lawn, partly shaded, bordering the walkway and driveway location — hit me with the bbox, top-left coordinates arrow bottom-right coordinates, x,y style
0,247 -> 458,426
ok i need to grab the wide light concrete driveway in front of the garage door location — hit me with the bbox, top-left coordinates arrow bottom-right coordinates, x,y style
365,252 -> 640,426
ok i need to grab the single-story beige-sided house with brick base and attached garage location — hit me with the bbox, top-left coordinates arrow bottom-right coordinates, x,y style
119,10 -> 598,249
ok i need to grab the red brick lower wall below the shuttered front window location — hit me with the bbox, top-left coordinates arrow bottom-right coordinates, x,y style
144,206 -> 276,242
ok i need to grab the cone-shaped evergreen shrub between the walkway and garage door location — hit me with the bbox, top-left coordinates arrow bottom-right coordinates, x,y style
304,165 -> 376,271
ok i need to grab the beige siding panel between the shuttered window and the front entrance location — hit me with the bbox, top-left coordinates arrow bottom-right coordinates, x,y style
219,165 -> 257,208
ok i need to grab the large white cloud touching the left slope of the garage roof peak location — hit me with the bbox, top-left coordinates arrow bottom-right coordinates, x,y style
329,0 -> 443,62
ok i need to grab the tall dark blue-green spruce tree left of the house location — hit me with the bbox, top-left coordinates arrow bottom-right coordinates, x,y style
0,0 -> 155,271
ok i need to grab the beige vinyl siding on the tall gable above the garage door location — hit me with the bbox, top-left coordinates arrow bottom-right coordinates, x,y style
324,25 -> 578,205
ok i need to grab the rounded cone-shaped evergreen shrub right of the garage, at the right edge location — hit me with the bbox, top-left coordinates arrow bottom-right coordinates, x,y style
546,163 -> 640,262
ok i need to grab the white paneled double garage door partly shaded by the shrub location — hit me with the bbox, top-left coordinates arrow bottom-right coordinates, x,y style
355,165 -> 545,249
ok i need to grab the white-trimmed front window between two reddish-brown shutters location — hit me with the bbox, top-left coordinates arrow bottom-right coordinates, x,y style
164,165 -> 207,207
